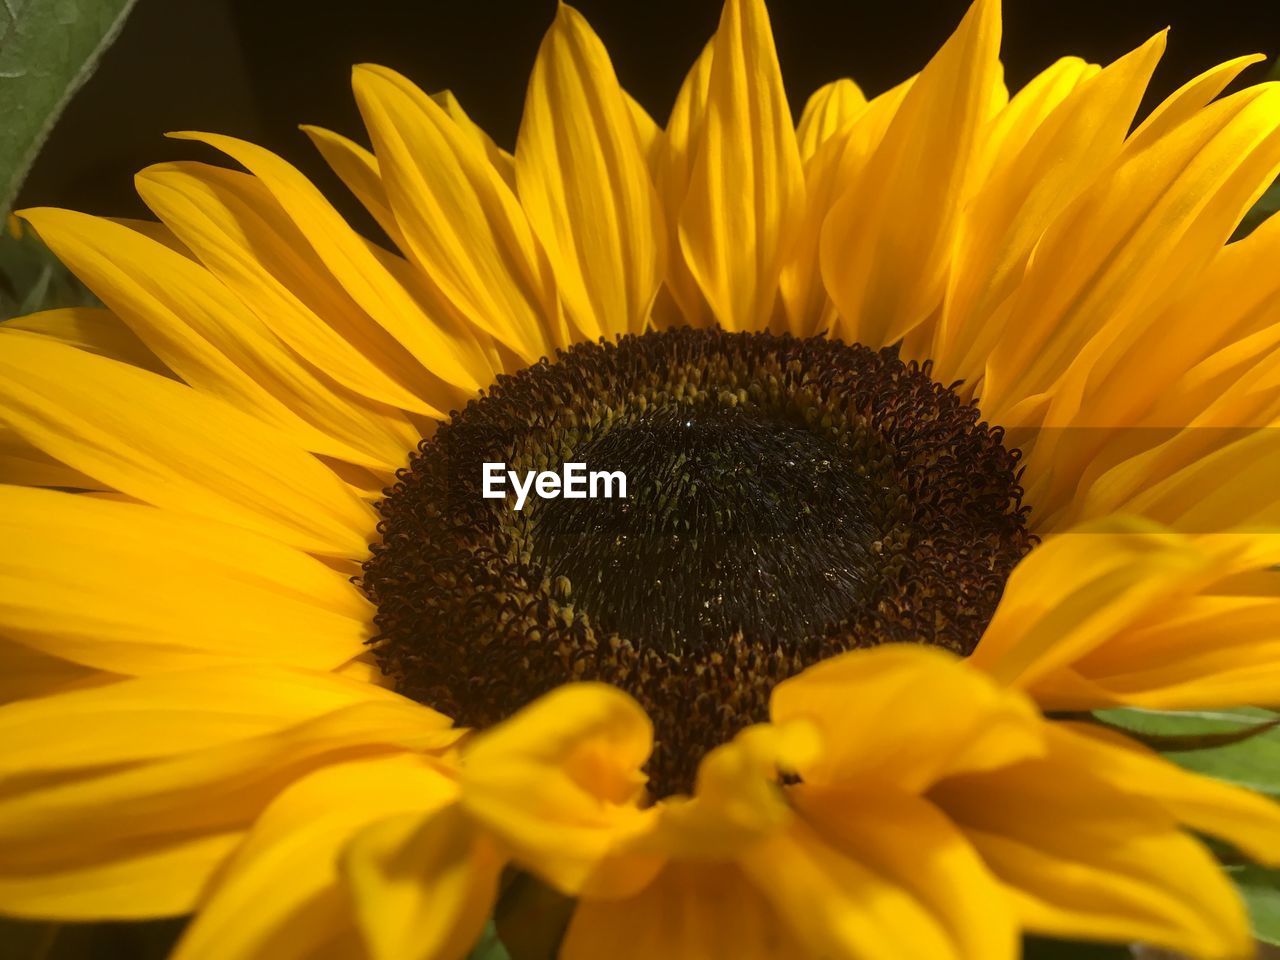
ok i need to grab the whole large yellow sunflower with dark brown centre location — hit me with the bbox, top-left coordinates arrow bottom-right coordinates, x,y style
0,0 -> 1280,960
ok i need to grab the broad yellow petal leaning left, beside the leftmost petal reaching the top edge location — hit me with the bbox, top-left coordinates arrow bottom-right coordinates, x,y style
352,65 -> 567,360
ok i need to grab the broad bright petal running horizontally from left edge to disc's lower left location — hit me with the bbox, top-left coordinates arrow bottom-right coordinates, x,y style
0,486 -> 372,673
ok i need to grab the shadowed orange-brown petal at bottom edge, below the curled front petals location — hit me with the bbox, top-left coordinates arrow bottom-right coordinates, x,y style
561,863 -> 809,960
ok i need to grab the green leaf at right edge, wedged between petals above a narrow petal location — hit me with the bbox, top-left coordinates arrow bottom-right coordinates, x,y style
1096,707 -> 1280,796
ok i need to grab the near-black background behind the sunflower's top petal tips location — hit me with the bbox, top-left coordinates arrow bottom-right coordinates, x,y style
19,0 -> 1280,227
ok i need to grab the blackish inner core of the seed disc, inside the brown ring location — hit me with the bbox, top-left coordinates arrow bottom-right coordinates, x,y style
532,403 -> 892,654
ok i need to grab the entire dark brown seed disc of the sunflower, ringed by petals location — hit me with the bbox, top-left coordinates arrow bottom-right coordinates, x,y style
362,330 -> 1032,795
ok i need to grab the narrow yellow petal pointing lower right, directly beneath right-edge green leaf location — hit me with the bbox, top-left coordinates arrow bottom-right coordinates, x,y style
1048,723 -> 1280,867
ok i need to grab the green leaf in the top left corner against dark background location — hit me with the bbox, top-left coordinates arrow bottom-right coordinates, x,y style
0,0 -> 133,218
